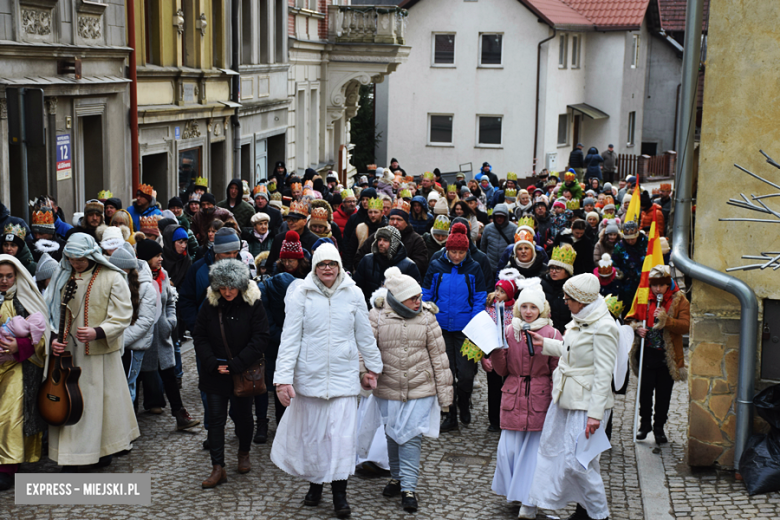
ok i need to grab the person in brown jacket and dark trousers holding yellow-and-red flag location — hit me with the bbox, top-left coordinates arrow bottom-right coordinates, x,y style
616,217 -> 690,444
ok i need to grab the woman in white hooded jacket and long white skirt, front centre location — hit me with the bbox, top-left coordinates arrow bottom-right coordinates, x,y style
271,244 -> 382,518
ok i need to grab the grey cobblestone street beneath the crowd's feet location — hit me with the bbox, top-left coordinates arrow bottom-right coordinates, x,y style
6,344 -> 780,520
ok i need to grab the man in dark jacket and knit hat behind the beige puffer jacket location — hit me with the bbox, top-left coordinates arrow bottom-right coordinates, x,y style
352,226 -> 422,308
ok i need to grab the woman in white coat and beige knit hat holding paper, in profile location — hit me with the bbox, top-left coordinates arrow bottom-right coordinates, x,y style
529,273 -> 619,520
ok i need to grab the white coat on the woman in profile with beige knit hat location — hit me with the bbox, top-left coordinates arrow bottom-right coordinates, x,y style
542,296 -> 619,421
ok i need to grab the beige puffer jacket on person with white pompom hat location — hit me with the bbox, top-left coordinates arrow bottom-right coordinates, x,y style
368,288 -> 453,408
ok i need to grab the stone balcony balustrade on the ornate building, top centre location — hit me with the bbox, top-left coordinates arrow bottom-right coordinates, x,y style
328,5 -> 408,45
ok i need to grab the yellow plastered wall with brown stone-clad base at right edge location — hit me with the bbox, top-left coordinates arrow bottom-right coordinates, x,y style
688,0 -> 780,466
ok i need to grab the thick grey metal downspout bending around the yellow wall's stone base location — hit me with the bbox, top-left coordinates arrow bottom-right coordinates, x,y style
672,0 -> 758,470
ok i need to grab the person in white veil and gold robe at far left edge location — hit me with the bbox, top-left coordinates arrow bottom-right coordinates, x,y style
0,254 -> 52,491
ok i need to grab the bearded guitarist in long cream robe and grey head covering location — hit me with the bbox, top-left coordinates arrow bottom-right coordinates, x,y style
46,233 -> 140,467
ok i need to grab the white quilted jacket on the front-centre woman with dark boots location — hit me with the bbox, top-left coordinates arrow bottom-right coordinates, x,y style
274,273 -> 382,399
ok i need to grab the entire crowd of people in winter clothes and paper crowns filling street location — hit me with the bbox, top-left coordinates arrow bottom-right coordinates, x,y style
0,156 -> 689,519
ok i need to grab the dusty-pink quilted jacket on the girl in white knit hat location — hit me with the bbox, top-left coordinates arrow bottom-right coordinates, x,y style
490,325 -> 563,432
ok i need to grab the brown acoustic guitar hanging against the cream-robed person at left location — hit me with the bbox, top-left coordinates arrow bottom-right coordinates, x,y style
38,278 -> 84,426
